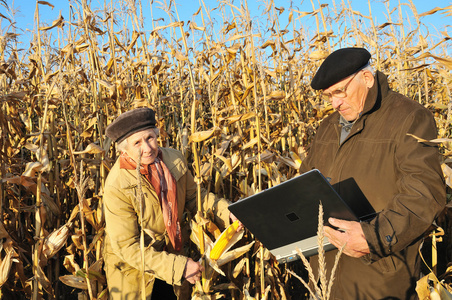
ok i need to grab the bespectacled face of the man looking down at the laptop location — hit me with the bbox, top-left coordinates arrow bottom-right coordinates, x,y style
323,71 -> 373,122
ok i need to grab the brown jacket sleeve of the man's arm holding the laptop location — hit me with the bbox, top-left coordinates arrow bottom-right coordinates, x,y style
361,109 -> 446,261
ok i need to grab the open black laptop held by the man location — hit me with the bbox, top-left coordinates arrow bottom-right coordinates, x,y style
229,169 -> 375,263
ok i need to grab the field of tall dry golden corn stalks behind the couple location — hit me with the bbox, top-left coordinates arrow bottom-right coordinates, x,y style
0,0 -> 452,299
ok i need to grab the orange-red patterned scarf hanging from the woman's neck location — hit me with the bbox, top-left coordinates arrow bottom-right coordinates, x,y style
119,148 -> 182,251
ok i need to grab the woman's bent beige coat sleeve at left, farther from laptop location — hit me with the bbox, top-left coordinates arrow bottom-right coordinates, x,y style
104,185 -> 187,285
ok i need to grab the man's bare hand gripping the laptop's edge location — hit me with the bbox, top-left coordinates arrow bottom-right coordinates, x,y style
324,218 -> 370,258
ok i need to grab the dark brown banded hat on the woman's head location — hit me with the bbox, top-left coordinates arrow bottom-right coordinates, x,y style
105,107 -> 157,143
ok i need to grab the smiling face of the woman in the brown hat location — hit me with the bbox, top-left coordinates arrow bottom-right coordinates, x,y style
125,128 -> 158,165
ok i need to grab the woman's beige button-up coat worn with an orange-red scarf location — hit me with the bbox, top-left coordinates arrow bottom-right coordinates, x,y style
103,148 -> 229,299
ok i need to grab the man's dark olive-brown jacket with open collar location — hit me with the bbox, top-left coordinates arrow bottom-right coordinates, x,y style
301,72 -> 446,299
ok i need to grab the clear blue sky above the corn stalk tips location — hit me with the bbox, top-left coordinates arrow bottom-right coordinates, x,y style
0,0 -> 452,50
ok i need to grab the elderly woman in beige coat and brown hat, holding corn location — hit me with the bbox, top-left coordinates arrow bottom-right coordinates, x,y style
103,108 -> 235,300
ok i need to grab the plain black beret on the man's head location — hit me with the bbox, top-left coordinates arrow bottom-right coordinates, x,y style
311,48 -> 370,90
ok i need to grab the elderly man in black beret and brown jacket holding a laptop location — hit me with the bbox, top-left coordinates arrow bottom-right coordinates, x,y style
301,48 -> 446,300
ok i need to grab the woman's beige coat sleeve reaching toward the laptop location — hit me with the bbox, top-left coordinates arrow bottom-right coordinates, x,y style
186,171 -> 230,228
